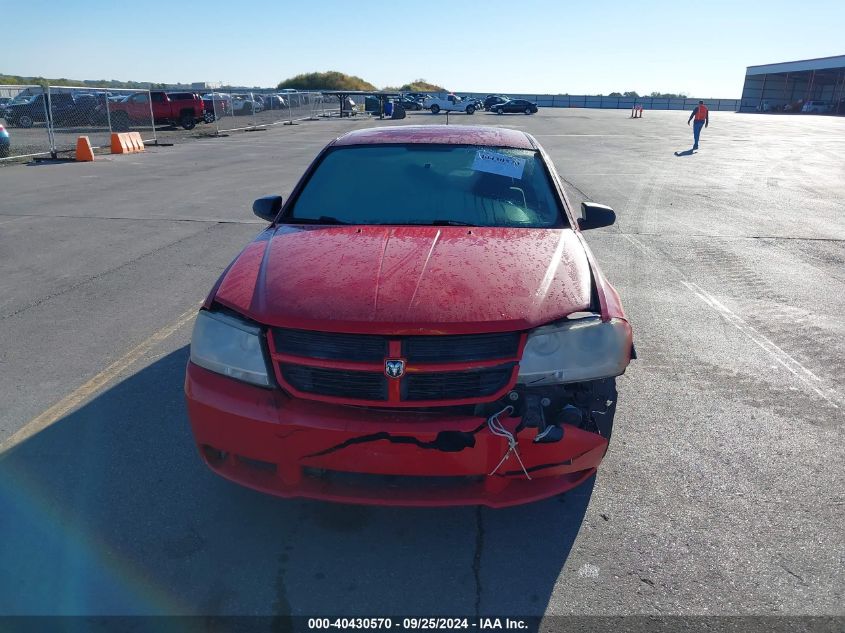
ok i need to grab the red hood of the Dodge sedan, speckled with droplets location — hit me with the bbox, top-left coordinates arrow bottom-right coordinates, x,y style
214,226 -> 592,334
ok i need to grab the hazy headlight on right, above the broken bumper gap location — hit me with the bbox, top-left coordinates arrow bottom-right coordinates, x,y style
518,316 -> 631,385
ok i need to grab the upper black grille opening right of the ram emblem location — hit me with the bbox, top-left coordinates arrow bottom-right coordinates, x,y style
402,332 -> 520,363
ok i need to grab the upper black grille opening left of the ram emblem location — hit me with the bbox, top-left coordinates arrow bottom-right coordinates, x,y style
273,329 -> 387,362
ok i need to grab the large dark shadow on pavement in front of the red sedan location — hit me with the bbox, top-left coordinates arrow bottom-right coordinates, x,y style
0,346 -> 593,617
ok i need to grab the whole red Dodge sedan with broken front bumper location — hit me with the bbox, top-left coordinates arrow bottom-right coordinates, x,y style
185,125 -> 633,507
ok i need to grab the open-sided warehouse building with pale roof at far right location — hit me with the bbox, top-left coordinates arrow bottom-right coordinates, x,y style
740,55 -> 845,115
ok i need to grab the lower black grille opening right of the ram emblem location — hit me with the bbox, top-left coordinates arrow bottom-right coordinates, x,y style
402,363 -> 514,401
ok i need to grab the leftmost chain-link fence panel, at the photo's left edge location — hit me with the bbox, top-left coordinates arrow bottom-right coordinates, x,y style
0,85 -> 53,160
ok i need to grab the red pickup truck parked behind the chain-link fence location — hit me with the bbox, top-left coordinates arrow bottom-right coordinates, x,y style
109,90 -> 205,130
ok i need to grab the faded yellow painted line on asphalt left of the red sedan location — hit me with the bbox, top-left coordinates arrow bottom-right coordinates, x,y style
0,306 -> 199,454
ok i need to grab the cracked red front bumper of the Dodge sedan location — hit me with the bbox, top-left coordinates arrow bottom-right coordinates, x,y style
185,363 -> 608,507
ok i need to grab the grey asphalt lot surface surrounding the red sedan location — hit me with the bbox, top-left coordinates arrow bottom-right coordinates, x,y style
0,109 -> 845,616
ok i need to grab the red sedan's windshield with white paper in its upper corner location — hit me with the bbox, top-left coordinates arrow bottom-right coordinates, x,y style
282,144 -> 565,228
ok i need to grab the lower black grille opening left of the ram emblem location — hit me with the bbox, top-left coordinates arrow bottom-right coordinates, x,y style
281,363 -> 387,400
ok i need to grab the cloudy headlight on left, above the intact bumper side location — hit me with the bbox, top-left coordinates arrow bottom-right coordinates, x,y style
191,310 -> 270,387
